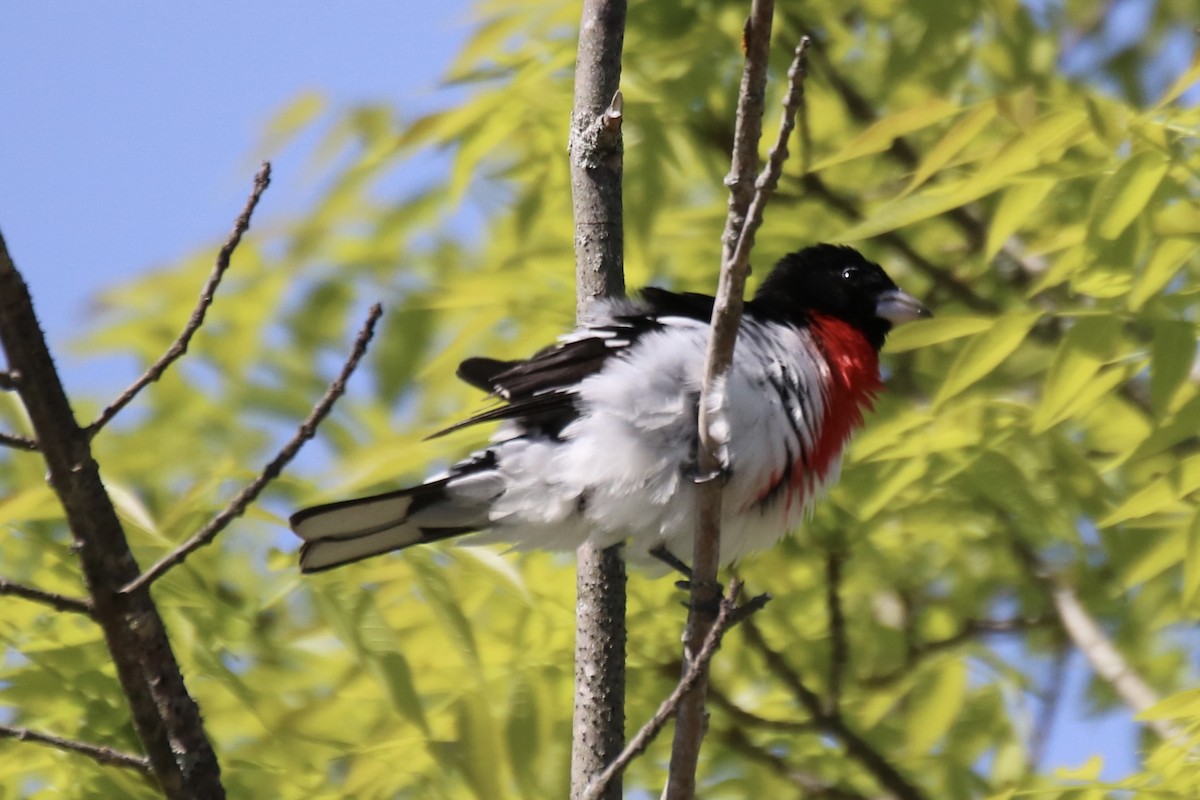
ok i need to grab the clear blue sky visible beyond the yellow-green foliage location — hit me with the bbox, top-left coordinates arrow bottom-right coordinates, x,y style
0,0 -> 1152,777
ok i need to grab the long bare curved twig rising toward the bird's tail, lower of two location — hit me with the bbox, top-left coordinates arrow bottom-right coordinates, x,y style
121,303 -> 383,594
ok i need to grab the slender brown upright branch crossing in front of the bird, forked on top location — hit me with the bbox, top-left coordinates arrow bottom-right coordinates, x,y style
664,26 -> 809,800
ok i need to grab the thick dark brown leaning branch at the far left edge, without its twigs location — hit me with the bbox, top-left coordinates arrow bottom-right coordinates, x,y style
0,226 -> 224,800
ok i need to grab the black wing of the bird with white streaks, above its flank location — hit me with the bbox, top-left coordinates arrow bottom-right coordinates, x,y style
441,287 -> 713,438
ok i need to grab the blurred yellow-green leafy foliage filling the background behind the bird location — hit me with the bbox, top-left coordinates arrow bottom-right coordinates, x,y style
0,0 -> 1200,798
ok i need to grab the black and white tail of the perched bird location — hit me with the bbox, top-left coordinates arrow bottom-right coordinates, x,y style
289,453 -> 496,572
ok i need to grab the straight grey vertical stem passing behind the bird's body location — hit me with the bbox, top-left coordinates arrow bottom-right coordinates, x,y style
569,0 -> 626,800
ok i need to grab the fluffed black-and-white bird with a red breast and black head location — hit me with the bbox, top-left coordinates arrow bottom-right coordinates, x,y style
289,243 -> 931,573
